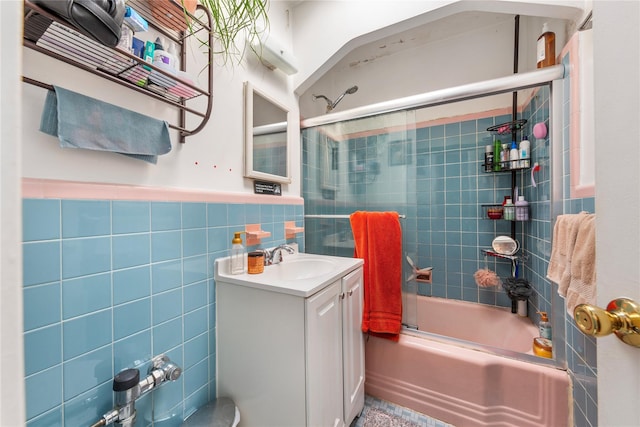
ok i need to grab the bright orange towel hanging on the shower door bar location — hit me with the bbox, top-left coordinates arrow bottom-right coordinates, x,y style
350,211 -> 402,341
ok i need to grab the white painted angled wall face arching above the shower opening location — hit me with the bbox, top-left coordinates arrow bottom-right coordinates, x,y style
293,0 -> 587,94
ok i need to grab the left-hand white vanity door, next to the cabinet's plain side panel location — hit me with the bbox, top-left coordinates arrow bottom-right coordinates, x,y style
306,281 -> 344,427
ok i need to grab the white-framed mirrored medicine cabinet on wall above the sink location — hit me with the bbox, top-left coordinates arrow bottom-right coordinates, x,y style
244,82 -> 291,183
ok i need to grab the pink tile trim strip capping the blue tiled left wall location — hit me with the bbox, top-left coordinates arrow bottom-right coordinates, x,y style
22,178 -> 304,205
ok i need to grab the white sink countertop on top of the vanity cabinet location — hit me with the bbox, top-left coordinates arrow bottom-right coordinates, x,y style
215,253 -> 364,298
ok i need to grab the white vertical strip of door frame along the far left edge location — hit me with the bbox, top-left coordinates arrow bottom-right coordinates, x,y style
0,1 -> 25,426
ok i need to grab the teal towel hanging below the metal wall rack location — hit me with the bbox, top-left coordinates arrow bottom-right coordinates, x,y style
40,86 -> 171,164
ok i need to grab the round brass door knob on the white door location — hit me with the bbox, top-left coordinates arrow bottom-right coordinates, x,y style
573,298 -> 640,347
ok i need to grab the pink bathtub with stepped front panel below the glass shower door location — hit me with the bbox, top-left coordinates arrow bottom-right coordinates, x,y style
365,296 -> 570,427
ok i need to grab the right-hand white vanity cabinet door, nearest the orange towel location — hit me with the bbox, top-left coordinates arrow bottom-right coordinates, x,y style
342,268 -> 364,425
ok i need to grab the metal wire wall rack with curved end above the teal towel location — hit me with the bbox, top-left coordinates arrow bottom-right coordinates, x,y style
22,0 -> 214,143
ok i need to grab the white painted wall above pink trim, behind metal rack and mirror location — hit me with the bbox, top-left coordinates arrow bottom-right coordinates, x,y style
22,2 -> 300,196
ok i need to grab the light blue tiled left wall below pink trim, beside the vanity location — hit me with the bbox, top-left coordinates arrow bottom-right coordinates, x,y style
23,199 -> 304,427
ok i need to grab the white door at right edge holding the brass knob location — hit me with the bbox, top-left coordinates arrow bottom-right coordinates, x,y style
592,1 -> 640,427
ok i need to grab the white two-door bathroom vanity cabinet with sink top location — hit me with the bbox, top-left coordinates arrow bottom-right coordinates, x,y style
216,254 -> 364,427
